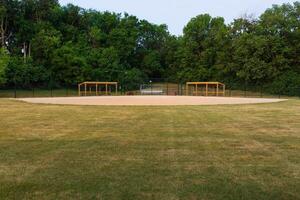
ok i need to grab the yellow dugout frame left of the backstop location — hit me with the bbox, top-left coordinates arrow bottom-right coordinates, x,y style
78,81 -> 118,96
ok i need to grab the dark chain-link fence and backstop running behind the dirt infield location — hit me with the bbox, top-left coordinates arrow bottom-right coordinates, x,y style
0,79 -> 300,98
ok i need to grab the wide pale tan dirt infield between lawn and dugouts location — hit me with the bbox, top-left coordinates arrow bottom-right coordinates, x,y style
19,96 -> 285,106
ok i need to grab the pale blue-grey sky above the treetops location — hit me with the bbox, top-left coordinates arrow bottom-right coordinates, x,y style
60,0 -> 296,35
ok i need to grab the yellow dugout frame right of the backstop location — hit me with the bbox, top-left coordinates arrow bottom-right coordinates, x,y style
186,82 -> 226,96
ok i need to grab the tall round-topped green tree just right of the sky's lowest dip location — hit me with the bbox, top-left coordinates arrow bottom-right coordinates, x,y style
178,14 -> 228,81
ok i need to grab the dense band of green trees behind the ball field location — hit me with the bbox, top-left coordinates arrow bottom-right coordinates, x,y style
0,0 -> 300,92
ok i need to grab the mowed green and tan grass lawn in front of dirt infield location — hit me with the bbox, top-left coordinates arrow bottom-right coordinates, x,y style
0,99 -> 300,200
